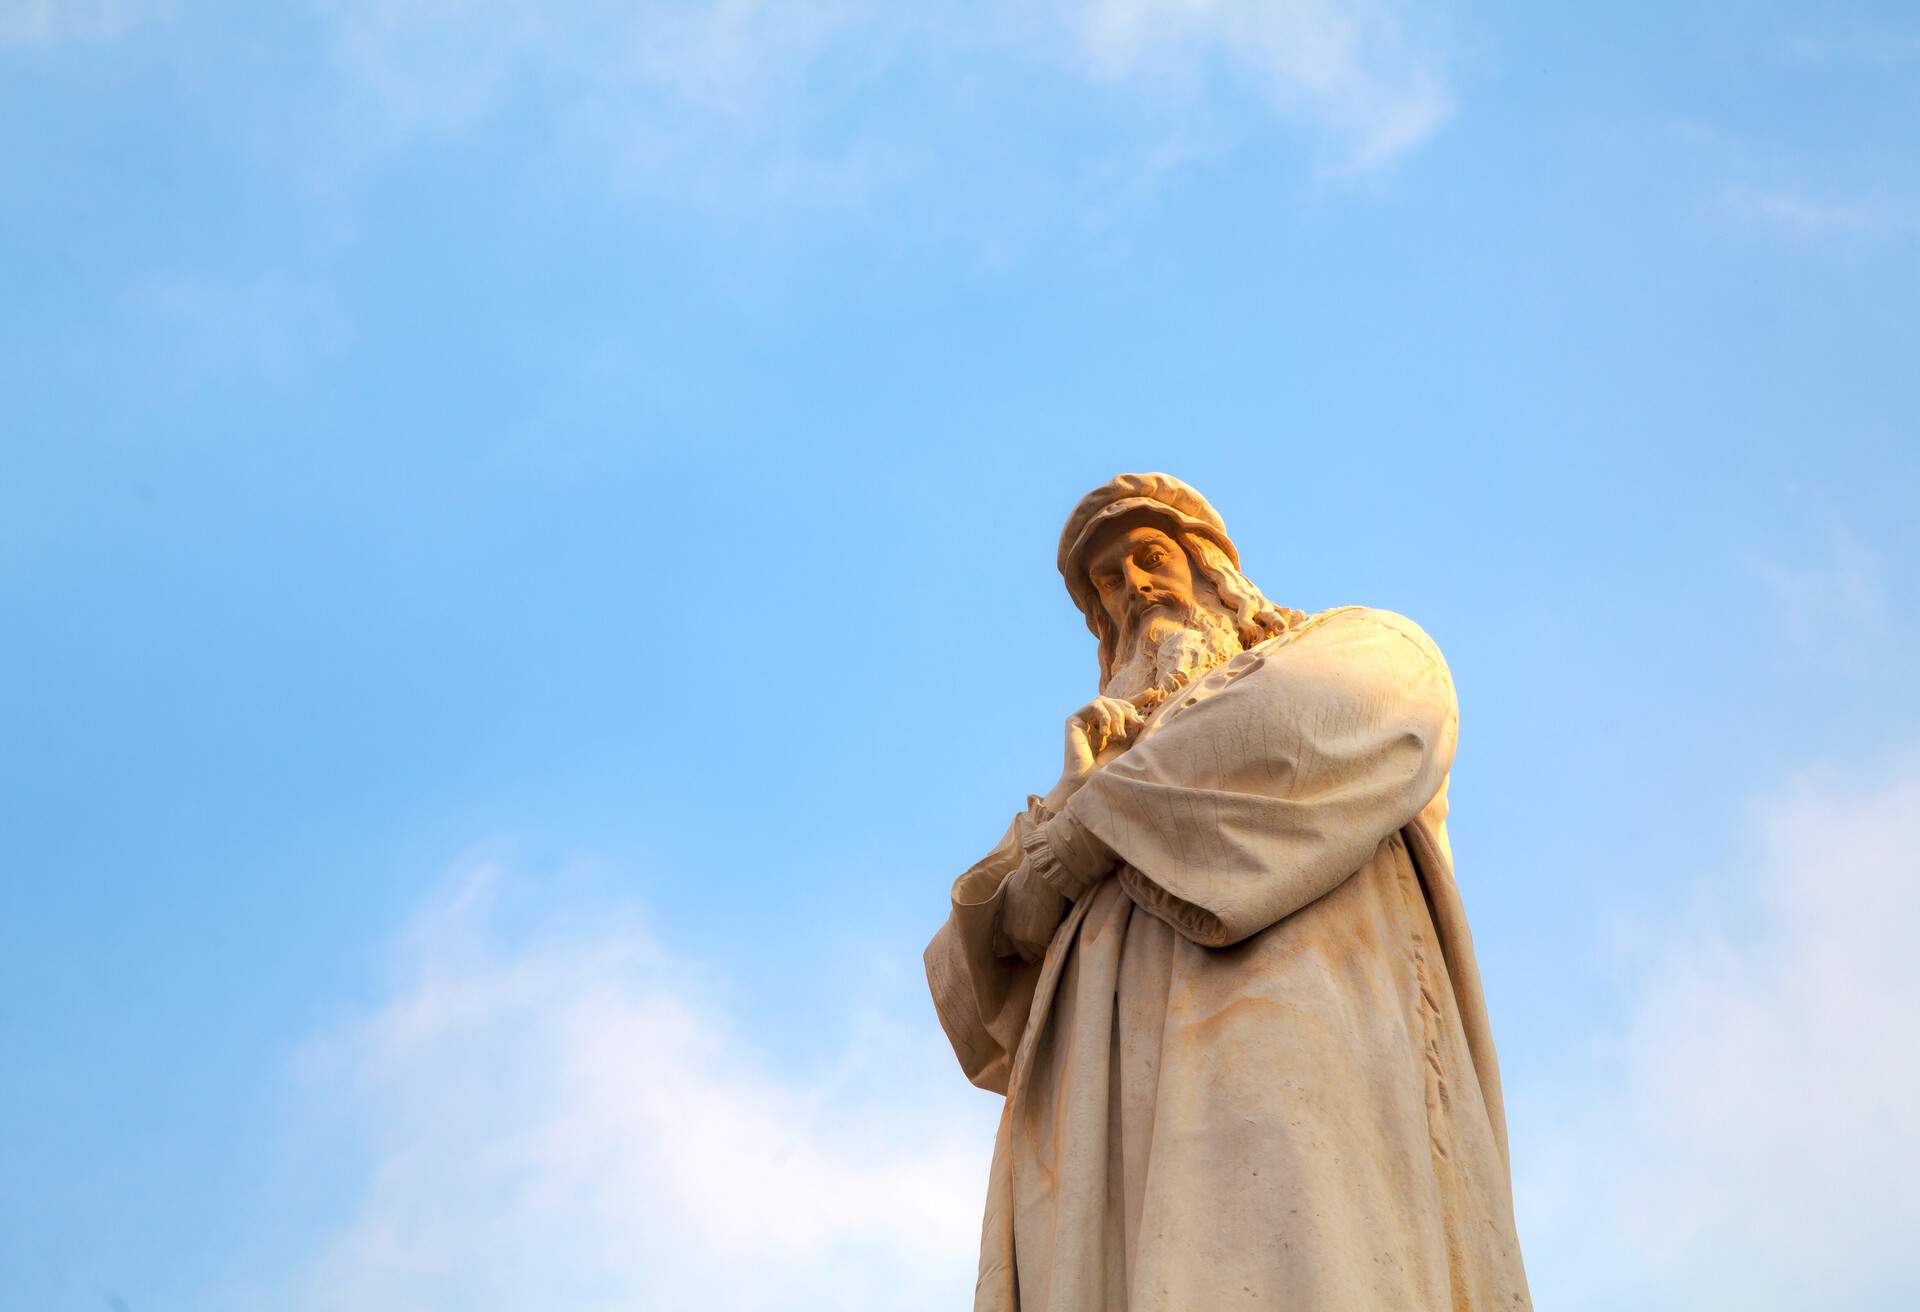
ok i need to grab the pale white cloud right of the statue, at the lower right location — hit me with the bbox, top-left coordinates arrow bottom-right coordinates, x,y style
1513,757 -> 1920,1312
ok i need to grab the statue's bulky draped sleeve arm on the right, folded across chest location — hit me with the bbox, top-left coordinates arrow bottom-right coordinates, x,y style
1046,611 -> 1459,947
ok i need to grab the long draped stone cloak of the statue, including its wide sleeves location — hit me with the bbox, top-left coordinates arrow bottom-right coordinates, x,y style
925,607 -> 1530,1312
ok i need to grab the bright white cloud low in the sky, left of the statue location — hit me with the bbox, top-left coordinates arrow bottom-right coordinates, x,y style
298,870 -> 996,1312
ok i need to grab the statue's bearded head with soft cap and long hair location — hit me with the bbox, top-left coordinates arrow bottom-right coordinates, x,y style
1060,474 -> 1300,707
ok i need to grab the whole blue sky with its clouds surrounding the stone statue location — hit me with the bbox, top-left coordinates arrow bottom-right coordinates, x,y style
0,0 -> 1920,1312
